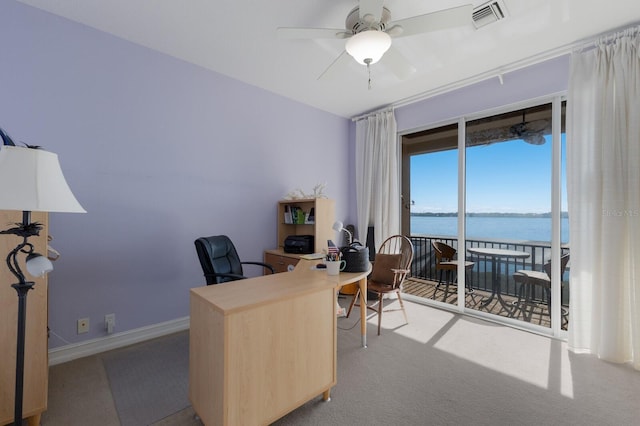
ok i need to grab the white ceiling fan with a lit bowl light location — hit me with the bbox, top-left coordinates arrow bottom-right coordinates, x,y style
277,0 -> 473,87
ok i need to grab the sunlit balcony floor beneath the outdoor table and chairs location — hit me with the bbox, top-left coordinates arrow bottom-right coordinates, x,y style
403,278 -> 567,329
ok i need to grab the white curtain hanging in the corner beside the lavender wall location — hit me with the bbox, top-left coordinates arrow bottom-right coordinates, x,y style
356,110 -> 400,249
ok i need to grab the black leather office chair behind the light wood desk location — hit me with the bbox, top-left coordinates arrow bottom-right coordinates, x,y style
195,235 -> 274,285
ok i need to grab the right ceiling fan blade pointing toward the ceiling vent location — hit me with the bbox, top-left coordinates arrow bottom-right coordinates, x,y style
389,4 -> 473,37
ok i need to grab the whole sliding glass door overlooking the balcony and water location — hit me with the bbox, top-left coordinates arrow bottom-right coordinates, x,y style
402,101 -> 570,329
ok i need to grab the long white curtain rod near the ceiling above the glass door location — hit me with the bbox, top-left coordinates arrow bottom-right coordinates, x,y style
351,22 -> 640,117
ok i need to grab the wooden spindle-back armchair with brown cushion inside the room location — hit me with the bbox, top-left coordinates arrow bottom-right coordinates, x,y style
347,235 -> 413,336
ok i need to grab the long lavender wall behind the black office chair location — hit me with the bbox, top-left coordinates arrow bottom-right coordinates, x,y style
0,2 -> 352,348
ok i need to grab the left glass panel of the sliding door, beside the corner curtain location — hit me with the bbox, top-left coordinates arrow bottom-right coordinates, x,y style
402,124 -> 459,305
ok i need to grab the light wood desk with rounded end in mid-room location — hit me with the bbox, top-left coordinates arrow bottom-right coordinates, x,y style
189,260 -> 369,426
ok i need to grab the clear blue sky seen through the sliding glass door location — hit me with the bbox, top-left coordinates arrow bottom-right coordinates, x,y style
411,135 -> 567,213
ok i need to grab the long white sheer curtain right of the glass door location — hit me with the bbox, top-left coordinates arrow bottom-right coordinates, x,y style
567,27 -> 640,369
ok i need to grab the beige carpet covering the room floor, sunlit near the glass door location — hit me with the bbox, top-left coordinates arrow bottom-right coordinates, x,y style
43,300 -> 640,426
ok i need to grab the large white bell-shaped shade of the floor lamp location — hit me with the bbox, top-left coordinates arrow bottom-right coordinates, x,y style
0,145 -> 86,213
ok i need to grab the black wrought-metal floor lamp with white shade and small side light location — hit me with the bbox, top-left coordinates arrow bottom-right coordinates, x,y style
0,137 -> 86,426
